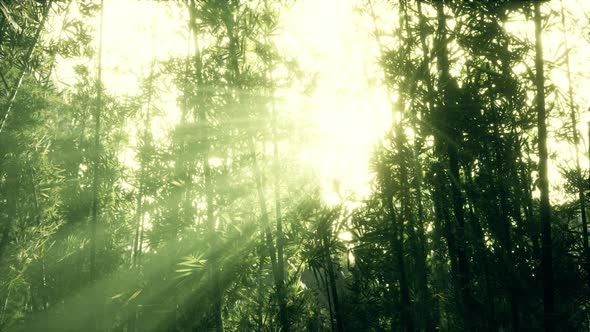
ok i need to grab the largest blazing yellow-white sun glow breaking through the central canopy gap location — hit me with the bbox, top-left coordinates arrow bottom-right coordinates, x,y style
279,0 -> 391,203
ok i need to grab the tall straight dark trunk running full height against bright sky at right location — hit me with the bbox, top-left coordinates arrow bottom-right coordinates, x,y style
534,1 -> 555,331
